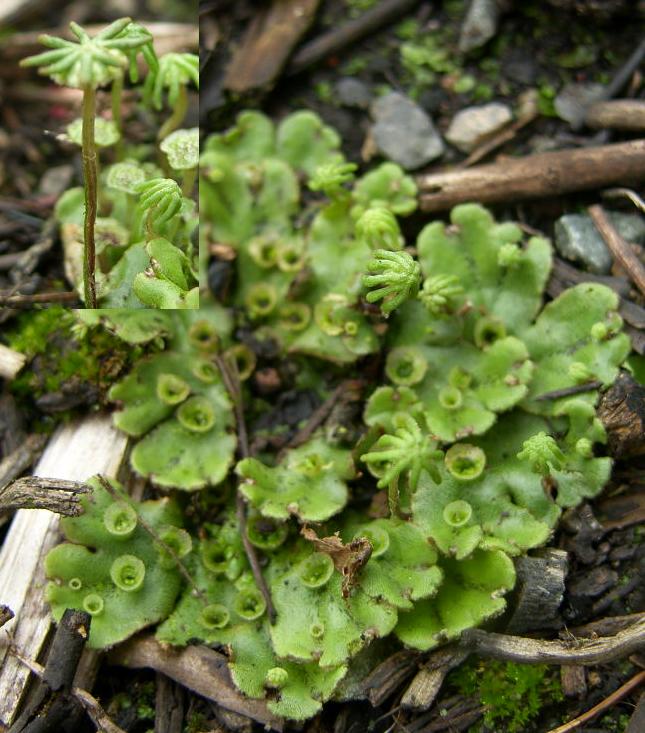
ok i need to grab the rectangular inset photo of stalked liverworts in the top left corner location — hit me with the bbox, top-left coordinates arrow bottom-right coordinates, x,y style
0,0 -> 199,308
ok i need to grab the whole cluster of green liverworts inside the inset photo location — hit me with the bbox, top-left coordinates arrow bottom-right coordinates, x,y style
23,18 -> 199,309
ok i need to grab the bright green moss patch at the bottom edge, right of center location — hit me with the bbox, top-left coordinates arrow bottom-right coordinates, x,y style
447,659 -> 564,733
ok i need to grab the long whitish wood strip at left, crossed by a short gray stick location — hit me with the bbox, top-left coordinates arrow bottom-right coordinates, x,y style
0,415 -> 127,726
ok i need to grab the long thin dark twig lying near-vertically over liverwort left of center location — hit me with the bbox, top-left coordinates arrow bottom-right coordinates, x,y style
215,355 -> 277,624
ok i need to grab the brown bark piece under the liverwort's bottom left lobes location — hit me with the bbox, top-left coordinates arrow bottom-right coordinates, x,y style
108,636 -> 283,731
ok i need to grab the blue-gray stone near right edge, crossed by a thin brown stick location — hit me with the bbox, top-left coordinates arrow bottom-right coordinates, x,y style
554,211 -> 645,275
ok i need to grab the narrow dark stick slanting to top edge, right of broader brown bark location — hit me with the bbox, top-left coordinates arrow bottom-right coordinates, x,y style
287,0 -> 419,75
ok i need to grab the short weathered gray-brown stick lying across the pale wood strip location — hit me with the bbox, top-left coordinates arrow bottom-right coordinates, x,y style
0,476 -> 90,517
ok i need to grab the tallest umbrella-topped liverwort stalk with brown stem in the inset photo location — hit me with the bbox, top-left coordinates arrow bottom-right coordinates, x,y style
21,18 -> 151,308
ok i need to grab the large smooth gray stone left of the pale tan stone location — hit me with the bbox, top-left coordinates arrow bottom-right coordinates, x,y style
371,92 -> 444,170
